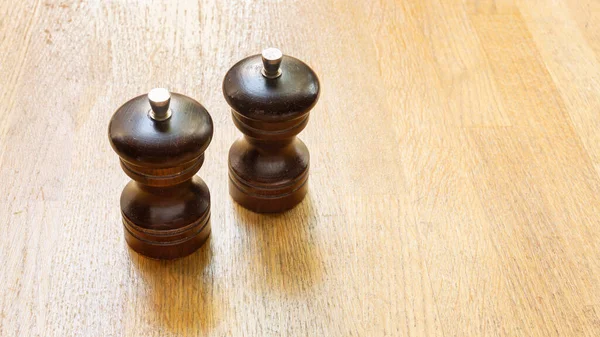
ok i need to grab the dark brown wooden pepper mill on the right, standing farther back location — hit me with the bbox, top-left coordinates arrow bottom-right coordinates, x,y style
223,48 -> 319,213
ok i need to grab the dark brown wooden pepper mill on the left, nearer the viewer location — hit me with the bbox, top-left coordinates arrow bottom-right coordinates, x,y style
108,88 -> 213,259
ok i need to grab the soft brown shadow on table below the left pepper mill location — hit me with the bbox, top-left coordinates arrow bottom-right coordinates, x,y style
129,237 -> 223,335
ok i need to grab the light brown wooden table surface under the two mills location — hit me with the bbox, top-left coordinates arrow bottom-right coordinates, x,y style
0,0 -> 600,336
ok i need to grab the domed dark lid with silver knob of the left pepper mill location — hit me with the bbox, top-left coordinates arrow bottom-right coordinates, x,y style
108,88 -> 213,167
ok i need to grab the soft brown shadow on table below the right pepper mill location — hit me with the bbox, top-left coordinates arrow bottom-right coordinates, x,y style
234,193 -> 323,295
